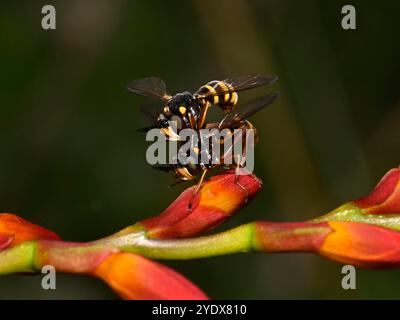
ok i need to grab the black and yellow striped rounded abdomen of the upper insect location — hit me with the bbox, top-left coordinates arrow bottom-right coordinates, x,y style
196,80 -> 238,112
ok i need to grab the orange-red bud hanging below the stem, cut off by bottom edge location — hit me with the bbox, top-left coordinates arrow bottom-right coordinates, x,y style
93,253 -> 208,300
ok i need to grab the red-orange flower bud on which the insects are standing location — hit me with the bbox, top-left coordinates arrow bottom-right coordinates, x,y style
140,171 -> 261,239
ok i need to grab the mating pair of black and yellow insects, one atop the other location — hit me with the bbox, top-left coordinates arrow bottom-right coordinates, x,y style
127,75 -> 278,201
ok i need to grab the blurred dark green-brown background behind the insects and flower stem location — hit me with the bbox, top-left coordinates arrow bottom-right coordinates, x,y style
0,0 -> 400,299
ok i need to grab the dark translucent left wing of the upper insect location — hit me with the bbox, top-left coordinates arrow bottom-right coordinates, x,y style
126,77 -> 171,102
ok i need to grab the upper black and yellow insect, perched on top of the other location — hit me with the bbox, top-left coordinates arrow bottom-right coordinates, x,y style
127,75 -> 278,139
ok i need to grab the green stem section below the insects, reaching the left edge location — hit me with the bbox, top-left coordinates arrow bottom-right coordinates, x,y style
0,223 -> 256,274
